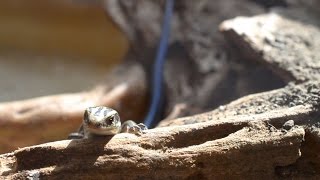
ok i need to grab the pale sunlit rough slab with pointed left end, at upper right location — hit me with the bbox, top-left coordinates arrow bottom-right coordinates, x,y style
221,13 -> 320,82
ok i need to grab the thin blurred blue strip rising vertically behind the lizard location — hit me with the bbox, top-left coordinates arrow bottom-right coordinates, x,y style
144,0 -> 174,128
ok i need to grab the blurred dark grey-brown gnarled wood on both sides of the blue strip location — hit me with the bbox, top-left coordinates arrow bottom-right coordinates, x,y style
107,0 -> 282,118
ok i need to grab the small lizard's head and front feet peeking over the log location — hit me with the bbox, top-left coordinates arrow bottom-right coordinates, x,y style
69,106 -> 148,139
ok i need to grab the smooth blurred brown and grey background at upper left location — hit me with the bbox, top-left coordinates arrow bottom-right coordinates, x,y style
0,0 -> 128,102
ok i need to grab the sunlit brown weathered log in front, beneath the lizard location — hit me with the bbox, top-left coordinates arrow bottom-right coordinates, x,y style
0,110 -> 305,179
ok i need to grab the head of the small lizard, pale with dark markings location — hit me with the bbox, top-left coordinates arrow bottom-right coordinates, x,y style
83,106 -> 121,135
